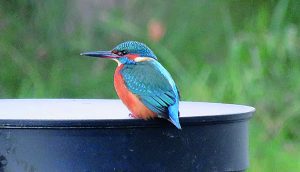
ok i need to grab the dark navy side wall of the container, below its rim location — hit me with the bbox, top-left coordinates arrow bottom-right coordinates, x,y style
0,120 -> 249,172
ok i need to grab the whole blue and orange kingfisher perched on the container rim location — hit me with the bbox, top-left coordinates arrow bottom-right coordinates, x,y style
80,41 -> 181,129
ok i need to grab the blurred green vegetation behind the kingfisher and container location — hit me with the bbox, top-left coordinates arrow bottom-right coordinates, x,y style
0,0 -> 300,172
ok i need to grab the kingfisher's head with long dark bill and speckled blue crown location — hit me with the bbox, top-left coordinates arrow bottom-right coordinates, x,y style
80,41 -> 157,65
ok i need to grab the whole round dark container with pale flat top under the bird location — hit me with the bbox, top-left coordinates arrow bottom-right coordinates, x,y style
0,99 -> 255,172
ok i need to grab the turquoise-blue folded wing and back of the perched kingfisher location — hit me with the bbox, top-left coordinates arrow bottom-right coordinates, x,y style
121,60 -> 179,119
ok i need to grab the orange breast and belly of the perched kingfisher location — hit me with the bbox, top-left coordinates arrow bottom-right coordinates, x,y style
114,64 -> 156,119
